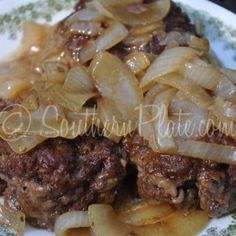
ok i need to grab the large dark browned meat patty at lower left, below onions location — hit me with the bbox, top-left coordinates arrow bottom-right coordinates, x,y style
0,136 -> 126,228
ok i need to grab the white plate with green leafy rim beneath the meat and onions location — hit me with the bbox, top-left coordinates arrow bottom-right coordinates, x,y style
0,0 -> 236,236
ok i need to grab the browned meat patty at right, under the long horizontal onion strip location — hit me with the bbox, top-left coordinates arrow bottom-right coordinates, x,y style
124,131 -> 236,217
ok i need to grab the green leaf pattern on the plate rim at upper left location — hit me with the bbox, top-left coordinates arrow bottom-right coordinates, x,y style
0,0 -> 78,39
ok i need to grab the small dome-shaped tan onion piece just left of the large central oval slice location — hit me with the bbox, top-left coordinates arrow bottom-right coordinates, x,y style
63,66 -> 95,93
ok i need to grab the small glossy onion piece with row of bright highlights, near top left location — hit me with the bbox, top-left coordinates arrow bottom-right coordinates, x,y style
70,21 -> 102,37
